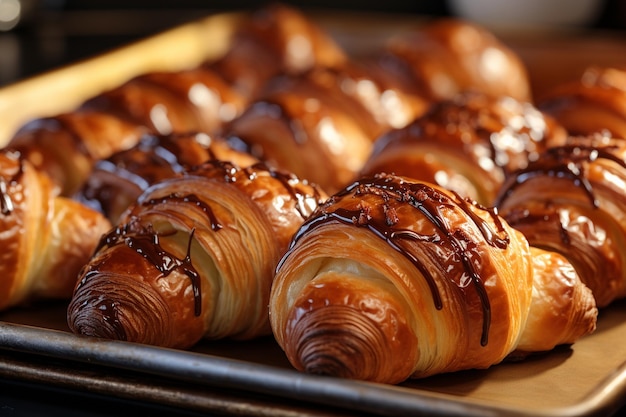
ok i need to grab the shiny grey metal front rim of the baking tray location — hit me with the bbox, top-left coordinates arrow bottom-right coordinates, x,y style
0,322 -> 626,417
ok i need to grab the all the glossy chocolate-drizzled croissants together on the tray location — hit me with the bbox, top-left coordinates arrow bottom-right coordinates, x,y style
0,4 -> 626,384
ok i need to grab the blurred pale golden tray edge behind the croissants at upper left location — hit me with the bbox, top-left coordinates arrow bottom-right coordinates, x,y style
0,14 -> 238,145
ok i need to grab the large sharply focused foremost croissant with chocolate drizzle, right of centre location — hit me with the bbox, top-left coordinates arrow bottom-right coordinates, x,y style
270,174 -> 597,383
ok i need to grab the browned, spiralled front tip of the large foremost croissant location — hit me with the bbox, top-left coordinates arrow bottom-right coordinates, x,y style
276,272 -> 417,384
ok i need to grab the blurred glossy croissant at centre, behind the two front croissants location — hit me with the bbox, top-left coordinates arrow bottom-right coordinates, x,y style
224,71 -> 380,192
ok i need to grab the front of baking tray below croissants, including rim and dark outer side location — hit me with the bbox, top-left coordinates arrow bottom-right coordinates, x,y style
0,302 -> 626,417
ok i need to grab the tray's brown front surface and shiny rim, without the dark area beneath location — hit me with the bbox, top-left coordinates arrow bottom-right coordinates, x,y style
0,302 -> 626,416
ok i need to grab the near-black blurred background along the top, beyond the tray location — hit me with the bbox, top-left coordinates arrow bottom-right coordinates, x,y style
0,0 -> 626,86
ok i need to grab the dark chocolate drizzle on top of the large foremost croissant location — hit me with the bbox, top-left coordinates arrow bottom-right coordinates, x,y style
278,175 -> 509,346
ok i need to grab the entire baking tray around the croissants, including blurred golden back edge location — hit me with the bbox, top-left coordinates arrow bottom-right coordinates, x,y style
0,8 -> 626,417
